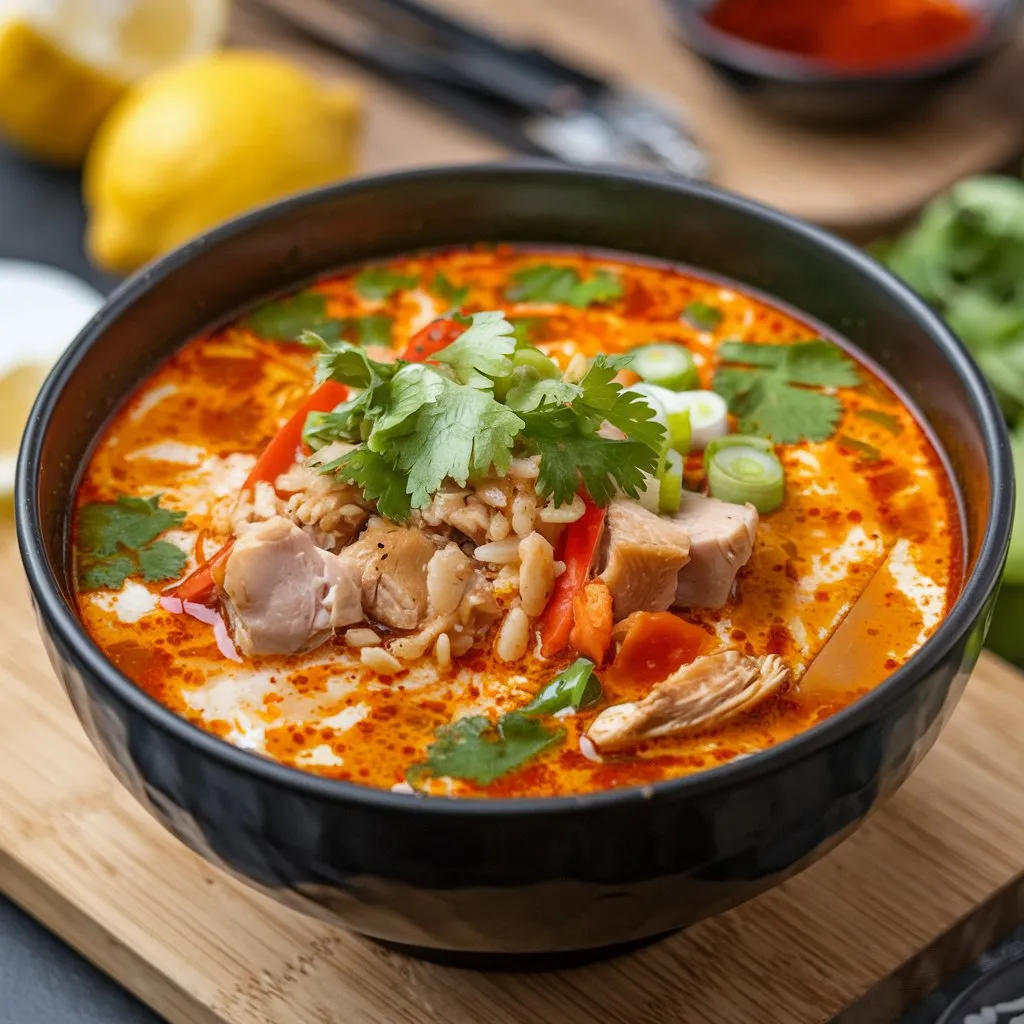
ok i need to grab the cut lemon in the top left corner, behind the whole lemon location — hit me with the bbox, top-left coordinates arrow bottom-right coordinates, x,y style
0,0 -> 229,166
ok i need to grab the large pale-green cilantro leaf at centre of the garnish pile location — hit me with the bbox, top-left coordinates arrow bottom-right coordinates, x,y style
390,371 -> 523,508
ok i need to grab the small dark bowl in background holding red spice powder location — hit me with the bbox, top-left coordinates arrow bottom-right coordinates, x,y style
666,0 -> 1021,126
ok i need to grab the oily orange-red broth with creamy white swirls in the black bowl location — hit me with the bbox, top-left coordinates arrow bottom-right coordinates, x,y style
72,247 -> 961,796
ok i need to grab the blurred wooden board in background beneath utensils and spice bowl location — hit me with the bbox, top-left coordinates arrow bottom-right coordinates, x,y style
232,0 -> 1024,240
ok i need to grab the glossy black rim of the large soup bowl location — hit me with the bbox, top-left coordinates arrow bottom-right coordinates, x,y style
15,159 -> 1015,818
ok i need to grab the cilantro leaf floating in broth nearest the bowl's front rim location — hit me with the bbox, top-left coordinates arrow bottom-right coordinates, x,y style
410,712 -> 565,785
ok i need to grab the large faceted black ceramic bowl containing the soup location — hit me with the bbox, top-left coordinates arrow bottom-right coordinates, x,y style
16,164 -> 1013,967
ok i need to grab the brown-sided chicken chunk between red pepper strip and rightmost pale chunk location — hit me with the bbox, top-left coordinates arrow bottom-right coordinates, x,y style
598,498 -> 690,622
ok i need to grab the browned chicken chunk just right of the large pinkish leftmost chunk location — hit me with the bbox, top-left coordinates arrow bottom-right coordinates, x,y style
359,522 -> 436,630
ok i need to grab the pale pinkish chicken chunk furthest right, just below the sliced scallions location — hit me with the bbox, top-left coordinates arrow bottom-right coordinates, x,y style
672,492 -> 758,608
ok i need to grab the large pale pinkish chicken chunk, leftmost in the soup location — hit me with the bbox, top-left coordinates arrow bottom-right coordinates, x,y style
223,516 -> 338,654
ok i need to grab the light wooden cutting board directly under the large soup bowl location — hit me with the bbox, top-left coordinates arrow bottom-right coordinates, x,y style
0,524 -> 1024,1024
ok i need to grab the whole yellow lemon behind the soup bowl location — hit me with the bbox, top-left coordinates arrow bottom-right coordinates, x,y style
85,50 -> 359,273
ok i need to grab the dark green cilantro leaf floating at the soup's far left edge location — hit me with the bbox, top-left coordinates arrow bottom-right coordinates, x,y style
76,495 -> 186,591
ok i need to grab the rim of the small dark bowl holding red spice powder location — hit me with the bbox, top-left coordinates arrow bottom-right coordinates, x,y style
665,0 -> 1019,86
